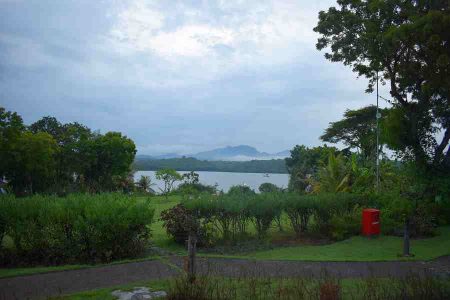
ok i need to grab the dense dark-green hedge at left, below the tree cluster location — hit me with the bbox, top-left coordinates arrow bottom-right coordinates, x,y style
0,194 -> 153,264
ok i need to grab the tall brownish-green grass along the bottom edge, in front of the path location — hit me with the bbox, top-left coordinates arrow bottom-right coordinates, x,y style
166,274 -> 450,300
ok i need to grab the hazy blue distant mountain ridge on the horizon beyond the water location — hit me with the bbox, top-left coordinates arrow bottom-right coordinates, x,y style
137,145 -> 290,161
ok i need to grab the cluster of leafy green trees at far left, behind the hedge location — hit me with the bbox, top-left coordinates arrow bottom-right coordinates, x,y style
0,107 -> 136,195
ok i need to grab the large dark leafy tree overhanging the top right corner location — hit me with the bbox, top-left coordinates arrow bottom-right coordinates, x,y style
314,0 -> 450,169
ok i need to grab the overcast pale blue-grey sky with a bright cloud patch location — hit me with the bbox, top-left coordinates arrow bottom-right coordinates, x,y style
0,0 -> 388,154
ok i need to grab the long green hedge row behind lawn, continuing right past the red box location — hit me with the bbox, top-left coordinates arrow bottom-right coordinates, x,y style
165,188 -> 440,246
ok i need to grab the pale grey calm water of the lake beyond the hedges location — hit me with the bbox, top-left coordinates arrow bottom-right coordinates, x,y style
134,171 -> 289,192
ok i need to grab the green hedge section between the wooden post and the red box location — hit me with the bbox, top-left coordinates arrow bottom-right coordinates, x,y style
174,191 -> 373,242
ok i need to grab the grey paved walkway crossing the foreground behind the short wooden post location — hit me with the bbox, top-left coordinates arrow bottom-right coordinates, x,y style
0,256 -> 450,300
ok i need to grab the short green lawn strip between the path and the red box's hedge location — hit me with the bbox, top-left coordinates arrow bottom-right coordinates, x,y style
206,226 -> 450,261
